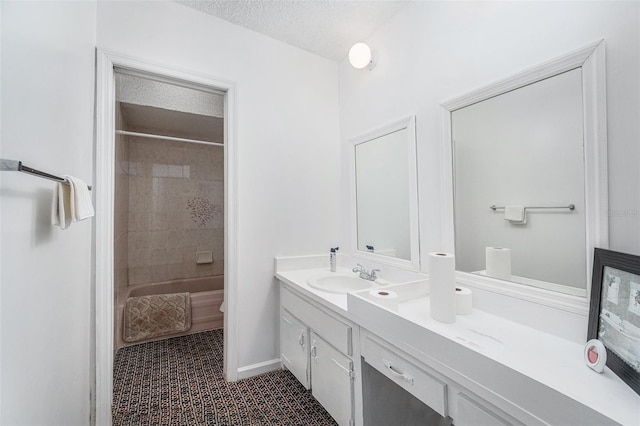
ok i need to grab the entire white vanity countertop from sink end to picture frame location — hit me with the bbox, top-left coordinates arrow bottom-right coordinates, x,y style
276,267 -> 640,426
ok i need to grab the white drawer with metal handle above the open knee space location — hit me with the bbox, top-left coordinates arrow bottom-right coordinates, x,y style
362,336 -> 447,417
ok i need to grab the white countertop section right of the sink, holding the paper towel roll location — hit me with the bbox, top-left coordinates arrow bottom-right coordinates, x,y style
356,287 -> 640,426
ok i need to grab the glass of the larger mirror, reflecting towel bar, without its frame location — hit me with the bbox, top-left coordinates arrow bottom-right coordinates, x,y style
451,69 -> 587,294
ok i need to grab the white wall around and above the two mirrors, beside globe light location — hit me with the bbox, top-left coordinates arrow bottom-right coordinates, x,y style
340,2 -> 640,269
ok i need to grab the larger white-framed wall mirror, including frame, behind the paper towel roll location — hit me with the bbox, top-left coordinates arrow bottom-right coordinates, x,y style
443,42 -> 608,298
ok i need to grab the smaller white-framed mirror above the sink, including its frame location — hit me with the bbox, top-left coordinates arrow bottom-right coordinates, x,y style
350,116 -> 420,270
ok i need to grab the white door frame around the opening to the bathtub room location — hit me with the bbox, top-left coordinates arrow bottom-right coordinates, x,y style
92,48 -> 238,425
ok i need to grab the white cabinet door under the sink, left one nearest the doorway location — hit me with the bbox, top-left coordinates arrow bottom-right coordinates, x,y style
280,309 -> 311,389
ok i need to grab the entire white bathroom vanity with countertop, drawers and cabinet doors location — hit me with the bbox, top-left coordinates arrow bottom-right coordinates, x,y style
275,256 -> 640,425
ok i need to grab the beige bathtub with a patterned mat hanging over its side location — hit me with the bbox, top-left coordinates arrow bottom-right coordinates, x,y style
114,275 -> 224,350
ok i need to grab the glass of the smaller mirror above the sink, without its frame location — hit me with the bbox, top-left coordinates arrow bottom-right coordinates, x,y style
355,128 -> 411,260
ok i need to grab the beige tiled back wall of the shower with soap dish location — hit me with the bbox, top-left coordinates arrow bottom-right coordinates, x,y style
128,136 -> 224,285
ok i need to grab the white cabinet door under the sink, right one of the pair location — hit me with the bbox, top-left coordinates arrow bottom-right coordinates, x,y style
311,332 -> 353,426
